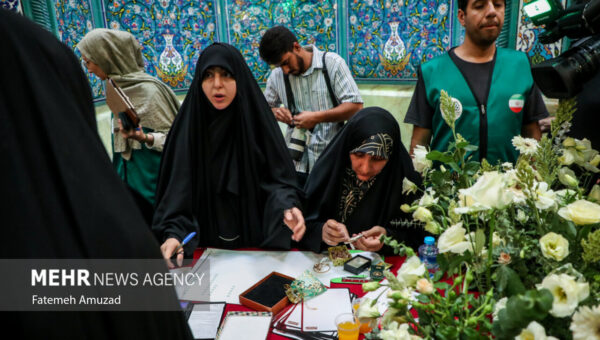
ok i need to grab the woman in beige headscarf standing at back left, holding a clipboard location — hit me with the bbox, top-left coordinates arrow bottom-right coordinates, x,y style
77,28 -> 179,219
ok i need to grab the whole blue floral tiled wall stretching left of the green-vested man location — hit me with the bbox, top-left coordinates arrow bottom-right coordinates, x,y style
47,0 -> 462,100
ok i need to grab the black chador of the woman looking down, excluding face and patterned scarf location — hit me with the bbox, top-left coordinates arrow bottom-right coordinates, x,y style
304,107 -> 423,251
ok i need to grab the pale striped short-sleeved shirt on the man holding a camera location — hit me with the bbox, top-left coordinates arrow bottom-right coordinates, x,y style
264,45 -> 363,173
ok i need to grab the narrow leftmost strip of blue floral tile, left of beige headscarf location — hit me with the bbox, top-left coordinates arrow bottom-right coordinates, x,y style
54,0 -> 104,99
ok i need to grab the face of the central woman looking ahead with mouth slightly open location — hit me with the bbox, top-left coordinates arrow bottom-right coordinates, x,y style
202,66 -> 237,110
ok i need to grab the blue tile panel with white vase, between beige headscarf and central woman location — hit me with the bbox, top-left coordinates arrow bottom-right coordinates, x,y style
103,0 -> 218,89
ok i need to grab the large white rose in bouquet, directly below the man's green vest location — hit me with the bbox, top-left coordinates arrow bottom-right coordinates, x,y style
454,171 -> 513,214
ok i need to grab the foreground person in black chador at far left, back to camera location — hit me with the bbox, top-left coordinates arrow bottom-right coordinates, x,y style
0,10 -> 192,339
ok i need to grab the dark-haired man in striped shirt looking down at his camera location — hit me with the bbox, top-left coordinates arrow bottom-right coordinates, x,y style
259,26 -> 363,186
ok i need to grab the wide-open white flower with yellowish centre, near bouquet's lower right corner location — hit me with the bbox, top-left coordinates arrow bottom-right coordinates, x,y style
536,274 -> 590,318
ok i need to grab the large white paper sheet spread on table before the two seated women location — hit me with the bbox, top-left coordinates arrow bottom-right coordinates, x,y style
178,248 -> 376,304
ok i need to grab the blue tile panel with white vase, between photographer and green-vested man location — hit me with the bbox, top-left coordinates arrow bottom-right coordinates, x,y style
347,0 -> 454,80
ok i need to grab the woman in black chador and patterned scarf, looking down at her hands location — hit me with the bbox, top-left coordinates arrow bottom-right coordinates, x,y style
303,107 -> 423,251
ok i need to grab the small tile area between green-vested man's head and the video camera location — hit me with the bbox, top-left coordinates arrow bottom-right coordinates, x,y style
516,0 -> 565,64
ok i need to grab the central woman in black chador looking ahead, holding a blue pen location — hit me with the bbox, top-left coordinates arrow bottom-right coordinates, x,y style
153,43 -> 305,262
